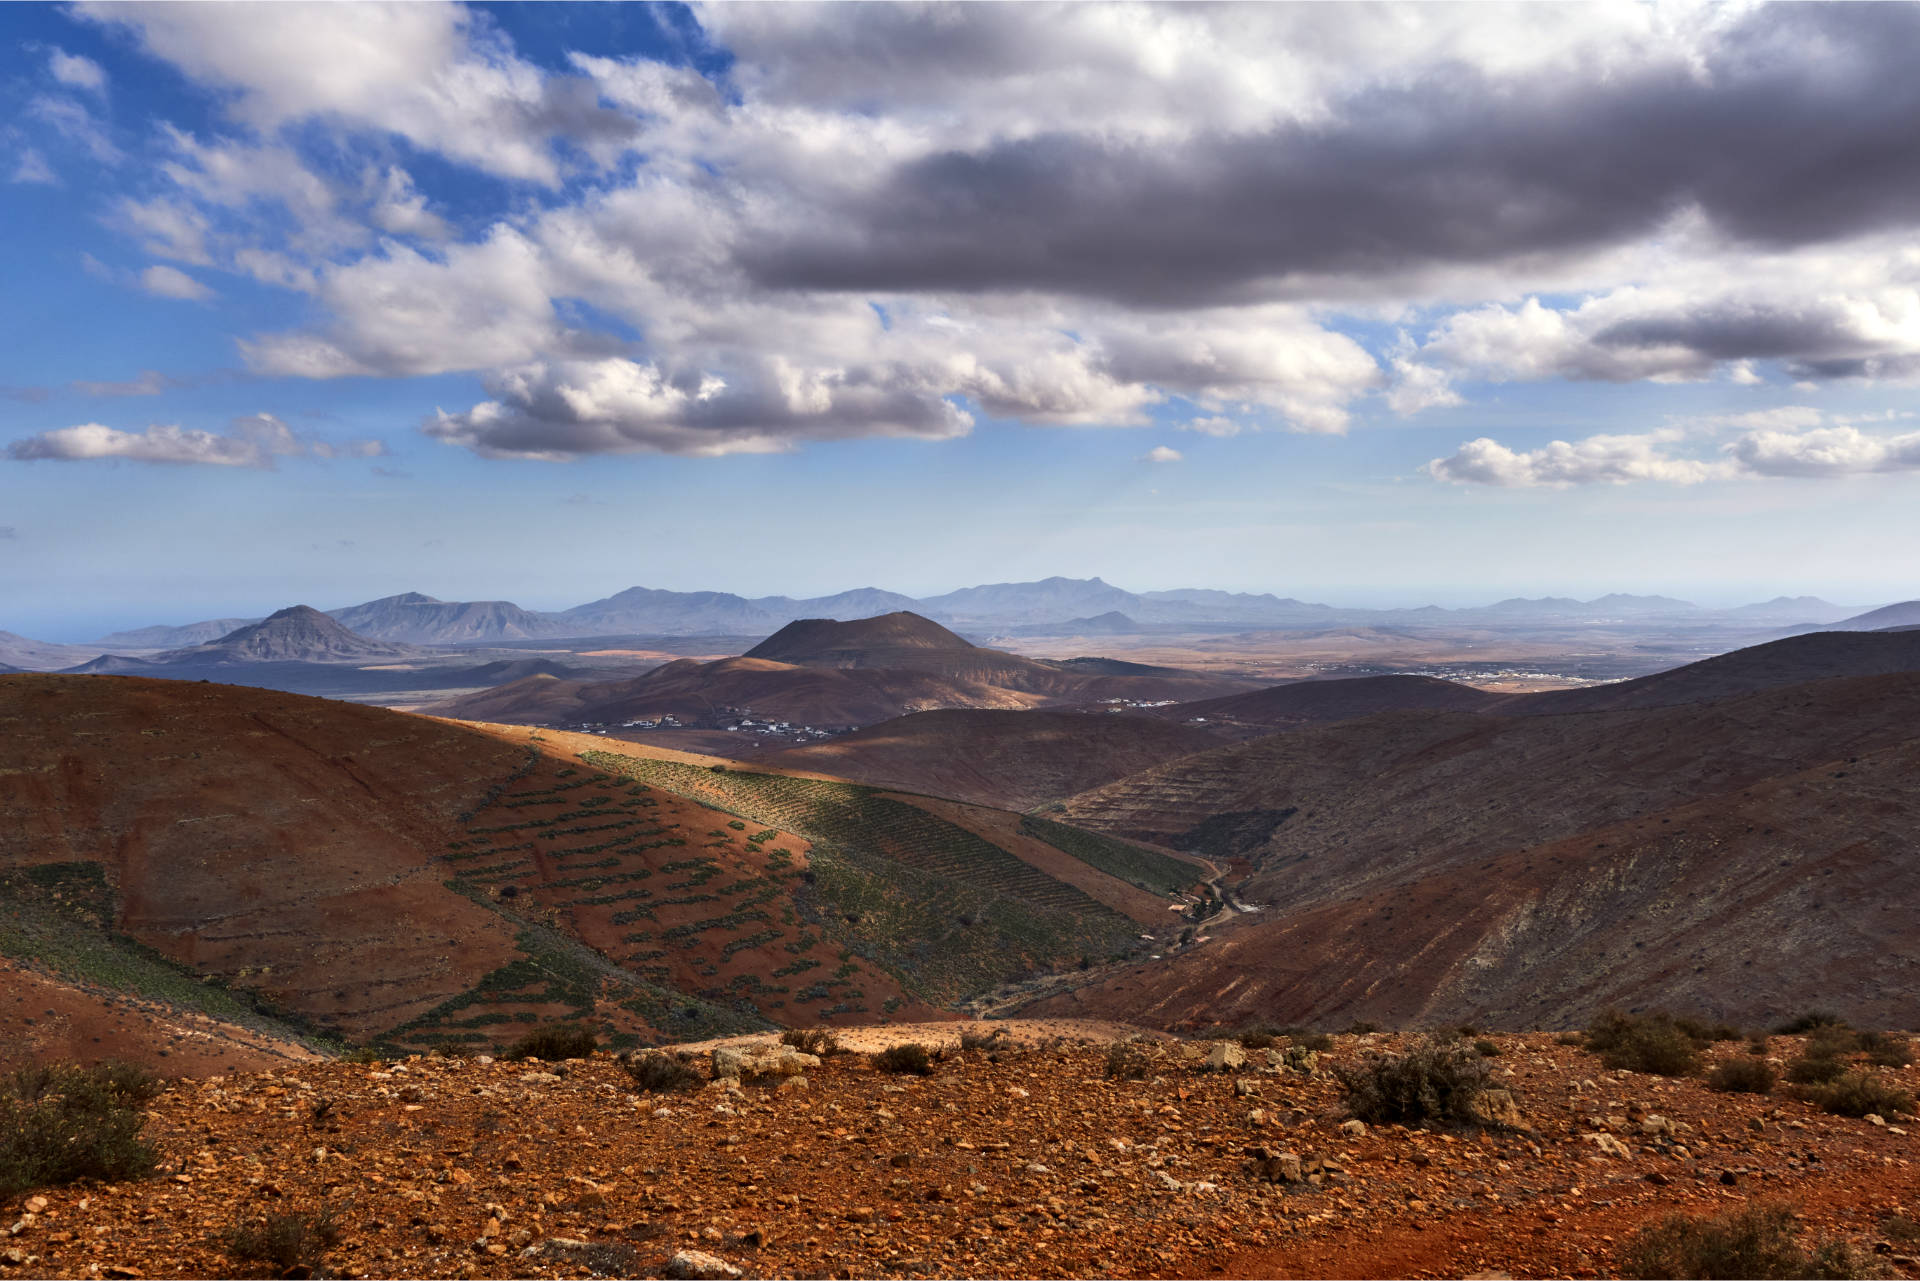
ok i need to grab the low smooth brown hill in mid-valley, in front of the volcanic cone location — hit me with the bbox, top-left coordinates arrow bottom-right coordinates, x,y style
755,709 -> 1219,810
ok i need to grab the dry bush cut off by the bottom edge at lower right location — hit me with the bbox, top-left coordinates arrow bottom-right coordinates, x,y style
1620,1206 -> 1872,1279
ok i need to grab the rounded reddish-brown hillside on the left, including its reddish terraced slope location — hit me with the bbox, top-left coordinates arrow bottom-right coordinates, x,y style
0,676 -> 940,1041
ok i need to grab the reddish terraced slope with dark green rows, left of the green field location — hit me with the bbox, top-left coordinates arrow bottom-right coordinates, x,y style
386,749 -> 927,1045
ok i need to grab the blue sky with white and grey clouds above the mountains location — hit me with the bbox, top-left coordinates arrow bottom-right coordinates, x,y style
0,4 -> 1920,640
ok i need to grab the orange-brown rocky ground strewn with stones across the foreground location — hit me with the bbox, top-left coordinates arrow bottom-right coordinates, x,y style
0,1024 -> 1920,1277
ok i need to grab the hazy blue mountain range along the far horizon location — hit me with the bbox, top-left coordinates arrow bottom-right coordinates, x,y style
45,578 -> 1889,666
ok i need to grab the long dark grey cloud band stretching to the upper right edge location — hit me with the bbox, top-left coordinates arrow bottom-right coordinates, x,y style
737,6 -> 1920,305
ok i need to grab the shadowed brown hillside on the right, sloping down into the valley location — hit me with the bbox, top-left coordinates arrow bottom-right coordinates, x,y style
1039,676 -> 1920,1026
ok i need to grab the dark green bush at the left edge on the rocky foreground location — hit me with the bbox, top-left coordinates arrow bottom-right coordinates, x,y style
0,1064 -> 163,1196
